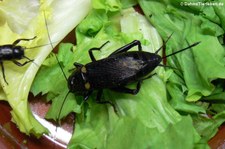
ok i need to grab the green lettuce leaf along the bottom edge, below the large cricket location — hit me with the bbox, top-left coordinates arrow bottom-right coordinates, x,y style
68,116 -> 202,149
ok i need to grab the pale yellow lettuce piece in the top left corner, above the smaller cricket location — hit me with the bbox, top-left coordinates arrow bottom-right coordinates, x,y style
0,0 -> 40,34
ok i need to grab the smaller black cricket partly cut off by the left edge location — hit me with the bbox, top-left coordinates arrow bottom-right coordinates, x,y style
0,36 -> 36,85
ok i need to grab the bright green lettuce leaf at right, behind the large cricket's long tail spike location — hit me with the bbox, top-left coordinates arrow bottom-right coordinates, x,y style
139,0 -> 225,101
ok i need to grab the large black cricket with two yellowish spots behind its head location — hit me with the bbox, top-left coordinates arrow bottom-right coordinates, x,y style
60,37 -> 200,111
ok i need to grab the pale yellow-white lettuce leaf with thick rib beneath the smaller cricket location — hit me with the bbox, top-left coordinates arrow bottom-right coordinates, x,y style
0,0 -> 91,137
